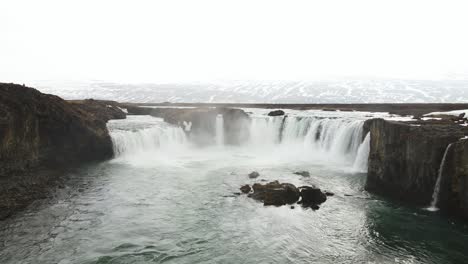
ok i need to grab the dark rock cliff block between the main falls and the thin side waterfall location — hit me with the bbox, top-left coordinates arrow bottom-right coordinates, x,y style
364,119 -> 468,205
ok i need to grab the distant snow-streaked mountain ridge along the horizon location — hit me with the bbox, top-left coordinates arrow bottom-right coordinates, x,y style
35,79 -> 468,103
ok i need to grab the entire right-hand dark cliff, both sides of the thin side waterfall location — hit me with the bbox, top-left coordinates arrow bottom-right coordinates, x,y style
364,116 -> 468,217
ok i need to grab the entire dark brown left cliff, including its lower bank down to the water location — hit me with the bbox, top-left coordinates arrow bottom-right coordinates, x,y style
0,83 -> 125,218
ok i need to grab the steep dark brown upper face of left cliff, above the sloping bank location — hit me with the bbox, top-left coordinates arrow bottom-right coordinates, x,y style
0,84 -> 117,174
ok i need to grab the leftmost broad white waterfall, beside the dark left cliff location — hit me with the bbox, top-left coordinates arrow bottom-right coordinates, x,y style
111,125 -> 187,157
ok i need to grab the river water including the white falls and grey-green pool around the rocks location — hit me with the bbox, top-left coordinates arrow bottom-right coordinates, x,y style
0,110 -> 468,264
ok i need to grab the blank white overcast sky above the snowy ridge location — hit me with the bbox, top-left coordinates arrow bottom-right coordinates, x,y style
0,0 -> 468,82
